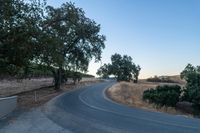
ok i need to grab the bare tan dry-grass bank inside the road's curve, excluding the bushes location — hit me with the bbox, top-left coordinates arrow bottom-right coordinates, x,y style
106,81 -> 190,116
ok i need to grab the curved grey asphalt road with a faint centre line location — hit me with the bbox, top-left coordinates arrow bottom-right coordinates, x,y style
45,81 -> 200,133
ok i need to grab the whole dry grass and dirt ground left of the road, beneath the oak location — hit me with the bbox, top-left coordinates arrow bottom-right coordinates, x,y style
0,78 -> 101,109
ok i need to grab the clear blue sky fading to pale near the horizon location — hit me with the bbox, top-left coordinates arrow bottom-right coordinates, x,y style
48,0 -> 200,78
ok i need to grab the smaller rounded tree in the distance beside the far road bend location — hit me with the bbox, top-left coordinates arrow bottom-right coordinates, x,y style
97,53 -> 141,83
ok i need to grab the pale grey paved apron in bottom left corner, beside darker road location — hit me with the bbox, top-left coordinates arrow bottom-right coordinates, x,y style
0,108 -> 72,133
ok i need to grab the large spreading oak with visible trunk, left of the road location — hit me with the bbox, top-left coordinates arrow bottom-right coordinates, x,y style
41,3 -> 105,89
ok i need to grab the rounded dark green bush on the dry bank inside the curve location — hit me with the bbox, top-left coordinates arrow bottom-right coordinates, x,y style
143,85 -> 181,107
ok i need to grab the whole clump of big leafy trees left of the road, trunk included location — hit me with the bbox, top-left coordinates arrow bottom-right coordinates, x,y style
0,0 -> 106,90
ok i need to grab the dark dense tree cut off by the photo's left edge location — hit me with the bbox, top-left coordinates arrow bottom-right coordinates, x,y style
0,0 -> 45,75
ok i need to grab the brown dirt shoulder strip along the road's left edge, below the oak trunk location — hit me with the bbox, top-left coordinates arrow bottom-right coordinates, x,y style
18,80 -> 102,109
